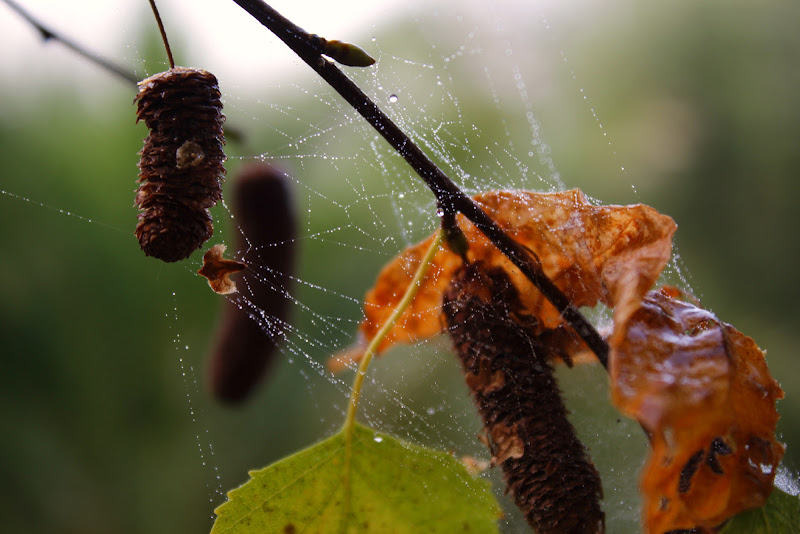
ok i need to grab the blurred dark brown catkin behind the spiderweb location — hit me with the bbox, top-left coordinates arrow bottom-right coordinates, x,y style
209,163 -> 297,404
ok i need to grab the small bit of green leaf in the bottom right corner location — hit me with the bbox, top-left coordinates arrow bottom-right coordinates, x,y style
720,488 -> 800,534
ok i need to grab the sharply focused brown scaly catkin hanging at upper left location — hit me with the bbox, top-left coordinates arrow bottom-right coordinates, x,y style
134,67 -> 225,262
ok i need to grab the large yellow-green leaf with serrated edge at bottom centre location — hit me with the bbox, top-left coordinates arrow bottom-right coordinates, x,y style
211,425 -> 501,534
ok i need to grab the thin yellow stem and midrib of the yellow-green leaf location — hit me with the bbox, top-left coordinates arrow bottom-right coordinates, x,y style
341,230 -> 444,532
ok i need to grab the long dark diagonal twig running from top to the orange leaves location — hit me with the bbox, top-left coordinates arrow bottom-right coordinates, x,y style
228,0 -> 608,368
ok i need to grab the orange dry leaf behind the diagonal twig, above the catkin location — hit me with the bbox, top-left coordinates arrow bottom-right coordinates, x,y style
331,189 -> 676,369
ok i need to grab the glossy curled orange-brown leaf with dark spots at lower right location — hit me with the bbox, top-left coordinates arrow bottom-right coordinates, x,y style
610,292 -> 784,534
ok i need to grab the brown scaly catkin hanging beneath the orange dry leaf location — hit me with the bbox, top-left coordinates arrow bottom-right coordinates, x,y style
443,262 -> 605,534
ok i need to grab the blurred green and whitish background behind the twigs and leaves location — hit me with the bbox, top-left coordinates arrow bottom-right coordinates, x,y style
0,0 -> 800,533
